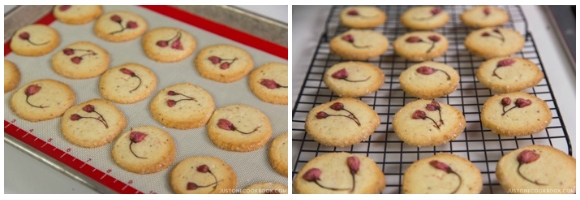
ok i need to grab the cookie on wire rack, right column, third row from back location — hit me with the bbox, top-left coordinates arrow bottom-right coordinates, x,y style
475,57 -> 544,93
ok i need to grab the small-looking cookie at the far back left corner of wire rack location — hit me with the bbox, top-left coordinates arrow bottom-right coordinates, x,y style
340,6 -> 387,29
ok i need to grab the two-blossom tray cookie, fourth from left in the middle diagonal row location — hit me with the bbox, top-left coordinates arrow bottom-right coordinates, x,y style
149,83 -> 215,130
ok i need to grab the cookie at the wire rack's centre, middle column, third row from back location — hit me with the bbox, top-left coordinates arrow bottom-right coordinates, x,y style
399,61 -> 459,99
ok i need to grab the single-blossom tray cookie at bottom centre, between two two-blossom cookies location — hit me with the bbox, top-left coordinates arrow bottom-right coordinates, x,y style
111,126 -> 176,174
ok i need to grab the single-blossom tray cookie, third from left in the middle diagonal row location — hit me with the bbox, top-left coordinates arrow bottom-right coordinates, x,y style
99,63 -> 157,104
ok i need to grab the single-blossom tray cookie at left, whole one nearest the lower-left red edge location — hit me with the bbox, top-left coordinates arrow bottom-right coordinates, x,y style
10,79 -> 76,122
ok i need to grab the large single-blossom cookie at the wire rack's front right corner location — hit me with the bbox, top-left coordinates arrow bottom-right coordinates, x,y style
495,145 -> 576,194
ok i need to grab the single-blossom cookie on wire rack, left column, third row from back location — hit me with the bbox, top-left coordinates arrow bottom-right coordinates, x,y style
322,61 -> 385,97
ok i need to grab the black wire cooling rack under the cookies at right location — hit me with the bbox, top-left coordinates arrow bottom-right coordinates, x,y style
292,6 -> 572,193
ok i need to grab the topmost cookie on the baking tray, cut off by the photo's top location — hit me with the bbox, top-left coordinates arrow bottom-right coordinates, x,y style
52,5 -> 103,24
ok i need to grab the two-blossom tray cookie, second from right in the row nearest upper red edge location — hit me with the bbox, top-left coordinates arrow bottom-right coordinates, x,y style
194,44 -> 254,83
